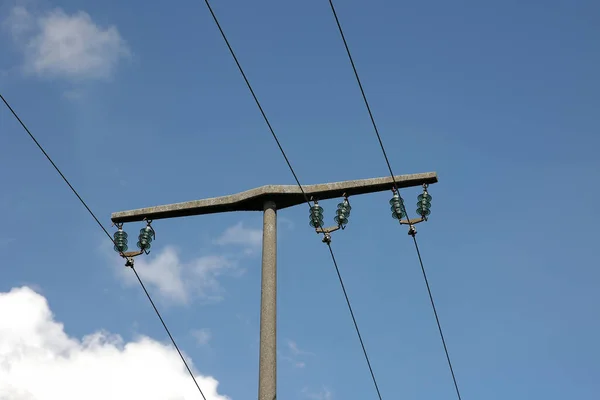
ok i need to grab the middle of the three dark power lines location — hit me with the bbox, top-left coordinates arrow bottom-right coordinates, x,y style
199,0 -> 382,400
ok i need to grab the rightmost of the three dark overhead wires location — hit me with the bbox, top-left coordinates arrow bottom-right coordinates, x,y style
328,0 -> 462,400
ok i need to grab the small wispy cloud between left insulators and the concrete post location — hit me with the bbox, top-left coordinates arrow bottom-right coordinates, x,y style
119,246 -> 236,304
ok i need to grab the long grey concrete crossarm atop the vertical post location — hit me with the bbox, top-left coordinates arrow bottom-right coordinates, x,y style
111,172 -> 438,223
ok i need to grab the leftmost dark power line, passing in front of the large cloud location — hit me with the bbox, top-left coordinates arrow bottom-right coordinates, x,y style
0,93 -> 206,400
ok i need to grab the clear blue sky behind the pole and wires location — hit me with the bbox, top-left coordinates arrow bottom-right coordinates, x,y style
0,0 -> 600,400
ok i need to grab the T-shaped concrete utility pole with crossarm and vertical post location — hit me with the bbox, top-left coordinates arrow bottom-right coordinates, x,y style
111,172 -> 437,400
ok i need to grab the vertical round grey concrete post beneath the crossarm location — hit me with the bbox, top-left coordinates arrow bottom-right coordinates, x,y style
258,201 -> 277,400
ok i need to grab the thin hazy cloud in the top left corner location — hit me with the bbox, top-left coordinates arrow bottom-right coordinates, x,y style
3,6 -> 130,80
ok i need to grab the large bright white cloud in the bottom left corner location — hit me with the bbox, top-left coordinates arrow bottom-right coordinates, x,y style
0,287 -> 229,400
